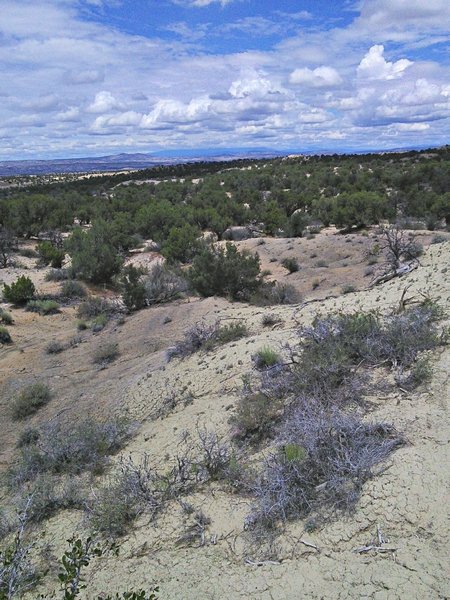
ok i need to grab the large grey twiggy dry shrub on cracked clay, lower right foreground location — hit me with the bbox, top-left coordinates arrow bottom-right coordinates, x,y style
248,404 -> 404,529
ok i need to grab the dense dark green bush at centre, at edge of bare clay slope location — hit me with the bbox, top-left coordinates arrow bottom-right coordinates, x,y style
189,243 -> 261,301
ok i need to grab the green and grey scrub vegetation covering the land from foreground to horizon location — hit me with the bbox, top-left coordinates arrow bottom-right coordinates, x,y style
0,147 -> 450,600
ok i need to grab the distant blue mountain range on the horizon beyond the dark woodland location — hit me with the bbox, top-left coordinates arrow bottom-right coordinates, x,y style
0,148 -> 288,177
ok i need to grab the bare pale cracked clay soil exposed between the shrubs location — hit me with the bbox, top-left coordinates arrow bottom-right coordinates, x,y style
0,230 -> 450,600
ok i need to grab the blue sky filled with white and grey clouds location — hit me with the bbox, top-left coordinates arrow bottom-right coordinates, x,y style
0,0 -> 450,160
